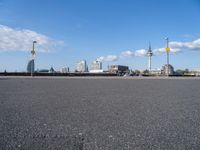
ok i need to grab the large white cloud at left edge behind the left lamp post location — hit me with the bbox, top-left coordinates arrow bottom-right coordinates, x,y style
0,25 -> 64,52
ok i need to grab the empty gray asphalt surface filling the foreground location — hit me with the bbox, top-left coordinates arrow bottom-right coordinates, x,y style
0,78 -> 200,150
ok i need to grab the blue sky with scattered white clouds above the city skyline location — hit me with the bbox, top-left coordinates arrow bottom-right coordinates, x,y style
0,0 -> 200,71
